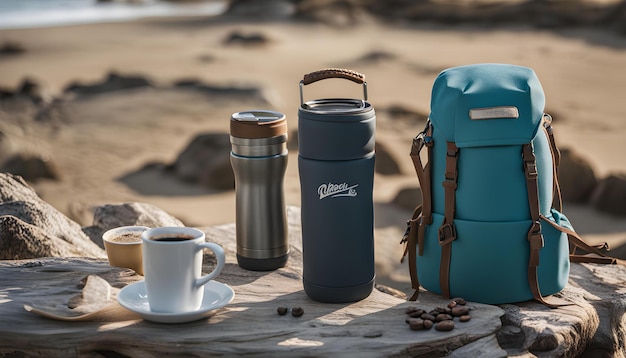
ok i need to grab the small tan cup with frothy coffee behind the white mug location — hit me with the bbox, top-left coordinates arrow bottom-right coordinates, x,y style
102,226 -> 149,275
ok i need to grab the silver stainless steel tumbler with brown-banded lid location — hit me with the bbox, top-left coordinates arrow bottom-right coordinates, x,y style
230,110 -> 289,271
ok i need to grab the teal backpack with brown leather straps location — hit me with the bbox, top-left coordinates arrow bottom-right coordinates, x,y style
403,64 -> 615,306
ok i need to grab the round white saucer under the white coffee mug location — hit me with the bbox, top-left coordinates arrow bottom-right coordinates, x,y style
117,281 -> 235,323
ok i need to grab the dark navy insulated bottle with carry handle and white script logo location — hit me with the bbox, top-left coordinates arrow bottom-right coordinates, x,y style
298,69 -> 376,302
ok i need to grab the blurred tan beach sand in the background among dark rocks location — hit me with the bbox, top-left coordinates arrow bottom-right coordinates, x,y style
0,14 -> 626,288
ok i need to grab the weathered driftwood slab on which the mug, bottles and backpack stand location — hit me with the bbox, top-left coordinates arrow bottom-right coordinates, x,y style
0,207 -> 626,357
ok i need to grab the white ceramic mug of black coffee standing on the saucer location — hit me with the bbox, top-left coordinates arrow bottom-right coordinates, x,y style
141,227 -> 226,313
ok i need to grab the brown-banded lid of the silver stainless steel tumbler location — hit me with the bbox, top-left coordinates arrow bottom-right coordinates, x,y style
230,110 -> 287,139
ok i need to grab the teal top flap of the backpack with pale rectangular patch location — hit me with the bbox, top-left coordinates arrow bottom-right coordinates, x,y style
430,64 -> 545,148
